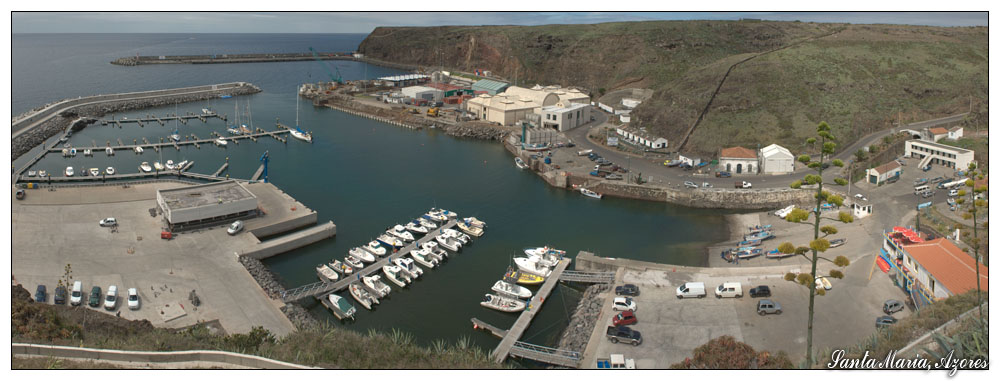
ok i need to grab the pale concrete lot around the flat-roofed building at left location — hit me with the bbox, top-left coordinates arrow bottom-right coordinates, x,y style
11,182 -> 293,336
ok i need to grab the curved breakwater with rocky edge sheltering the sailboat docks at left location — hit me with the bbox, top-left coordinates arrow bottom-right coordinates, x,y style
10,85 -> 261,160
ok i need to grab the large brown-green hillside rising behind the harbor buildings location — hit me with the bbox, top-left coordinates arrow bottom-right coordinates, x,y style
359,21 -> 989,153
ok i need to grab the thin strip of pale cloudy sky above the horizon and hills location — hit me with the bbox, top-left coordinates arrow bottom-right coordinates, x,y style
11,11 -> 989,33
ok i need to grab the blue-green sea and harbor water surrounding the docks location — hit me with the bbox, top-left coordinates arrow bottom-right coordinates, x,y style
13,34 -> 726,349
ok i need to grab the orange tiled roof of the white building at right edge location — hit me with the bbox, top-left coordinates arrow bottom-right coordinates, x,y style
903,238 -> 990,295
